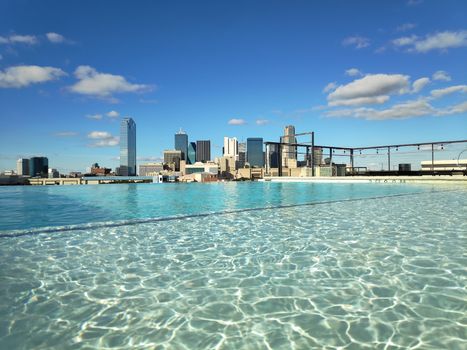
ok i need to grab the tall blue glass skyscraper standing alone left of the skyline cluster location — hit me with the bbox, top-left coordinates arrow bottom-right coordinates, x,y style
119,118 -> 136,176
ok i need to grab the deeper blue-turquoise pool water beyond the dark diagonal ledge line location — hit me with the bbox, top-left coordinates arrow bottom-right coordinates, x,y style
0,182 -> 442,233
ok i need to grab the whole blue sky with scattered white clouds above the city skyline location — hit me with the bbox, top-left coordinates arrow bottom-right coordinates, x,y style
0,0 -> 467,172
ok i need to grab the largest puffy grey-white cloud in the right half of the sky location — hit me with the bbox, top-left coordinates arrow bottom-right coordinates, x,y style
328,74 -> 409,106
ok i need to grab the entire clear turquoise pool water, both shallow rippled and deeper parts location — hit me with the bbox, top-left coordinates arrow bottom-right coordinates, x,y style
0,183 -> 467,349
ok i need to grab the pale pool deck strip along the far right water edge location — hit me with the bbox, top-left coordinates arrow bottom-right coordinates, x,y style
258,175 -> 467,185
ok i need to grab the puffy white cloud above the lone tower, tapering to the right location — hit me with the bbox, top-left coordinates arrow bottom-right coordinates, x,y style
70,66 -> 150,98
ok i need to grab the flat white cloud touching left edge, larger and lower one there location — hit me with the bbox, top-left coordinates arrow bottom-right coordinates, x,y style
0,66 -> 66,88
